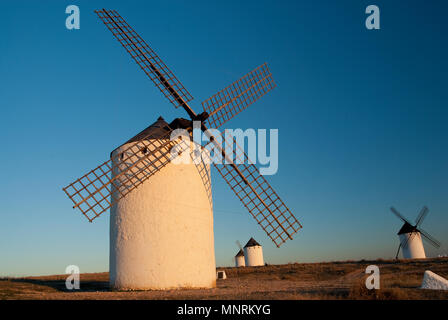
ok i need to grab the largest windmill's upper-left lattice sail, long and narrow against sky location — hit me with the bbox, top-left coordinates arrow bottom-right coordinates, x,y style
95,9 -> 193,108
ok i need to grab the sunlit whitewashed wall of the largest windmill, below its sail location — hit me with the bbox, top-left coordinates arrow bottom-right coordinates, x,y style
110,141 -> 216,289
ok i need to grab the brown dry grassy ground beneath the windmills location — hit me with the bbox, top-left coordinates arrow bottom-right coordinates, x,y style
0,258 -> 448,300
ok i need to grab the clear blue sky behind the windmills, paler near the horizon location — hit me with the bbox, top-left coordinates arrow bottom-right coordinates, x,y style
0,0 -> 448,276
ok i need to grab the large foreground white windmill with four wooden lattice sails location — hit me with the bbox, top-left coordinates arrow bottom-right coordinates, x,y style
63,9 -> 302,288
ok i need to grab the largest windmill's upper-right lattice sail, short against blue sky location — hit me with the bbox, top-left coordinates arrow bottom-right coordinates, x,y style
202,63 -> 276,128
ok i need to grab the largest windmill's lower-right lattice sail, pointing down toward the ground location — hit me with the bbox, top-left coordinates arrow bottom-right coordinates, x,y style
209,134 -> 302,247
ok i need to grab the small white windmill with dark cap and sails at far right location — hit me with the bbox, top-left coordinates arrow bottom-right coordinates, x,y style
390,206 -> 440,259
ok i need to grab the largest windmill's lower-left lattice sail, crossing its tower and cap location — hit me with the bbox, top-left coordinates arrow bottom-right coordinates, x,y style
63,126 -> 189,222
